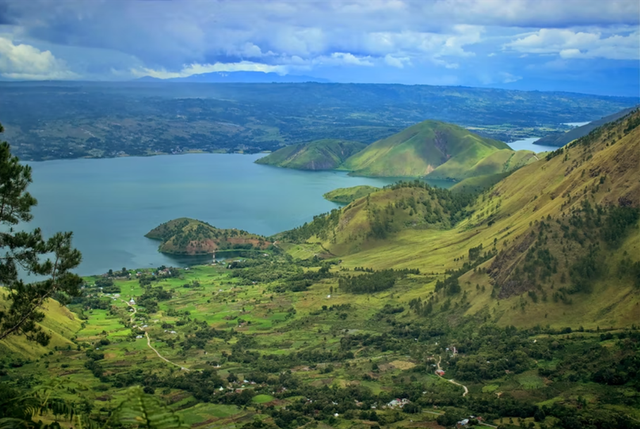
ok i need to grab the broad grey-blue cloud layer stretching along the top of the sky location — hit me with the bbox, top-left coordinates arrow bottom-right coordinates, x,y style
3,0 -> 639,67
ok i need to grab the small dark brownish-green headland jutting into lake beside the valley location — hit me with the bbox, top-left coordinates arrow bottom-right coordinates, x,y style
145,218 -> 270,255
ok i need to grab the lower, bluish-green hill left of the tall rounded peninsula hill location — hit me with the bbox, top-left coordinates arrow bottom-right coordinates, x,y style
256,139 -> 366,170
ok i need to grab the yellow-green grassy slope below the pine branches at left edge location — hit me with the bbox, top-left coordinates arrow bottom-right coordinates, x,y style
0,287 -> 82,360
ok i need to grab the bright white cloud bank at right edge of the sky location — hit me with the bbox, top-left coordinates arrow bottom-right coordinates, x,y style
503,29 -> 640,60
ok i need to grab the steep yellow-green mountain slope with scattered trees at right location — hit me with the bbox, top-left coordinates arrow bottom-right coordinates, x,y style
279,111 -> 640,329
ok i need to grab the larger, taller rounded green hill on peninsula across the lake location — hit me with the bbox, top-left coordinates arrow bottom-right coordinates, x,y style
340,121 -> 511,178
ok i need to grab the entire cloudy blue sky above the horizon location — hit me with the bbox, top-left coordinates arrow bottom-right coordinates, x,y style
0,0 -> 640,96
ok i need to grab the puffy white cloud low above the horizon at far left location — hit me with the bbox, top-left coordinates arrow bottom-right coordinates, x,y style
0,37 -> 78,80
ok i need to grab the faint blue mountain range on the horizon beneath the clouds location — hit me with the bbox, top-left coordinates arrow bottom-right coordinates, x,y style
136,71 -> 330,83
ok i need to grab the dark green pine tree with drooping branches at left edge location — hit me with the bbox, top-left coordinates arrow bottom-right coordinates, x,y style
0,125 -> 82,345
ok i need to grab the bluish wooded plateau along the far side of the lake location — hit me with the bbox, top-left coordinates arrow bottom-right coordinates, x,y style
0,82 -> 638,161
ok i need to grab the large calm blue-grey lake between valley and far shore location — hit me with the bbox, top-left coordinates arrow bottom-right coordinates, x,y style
29,154 -> 424,275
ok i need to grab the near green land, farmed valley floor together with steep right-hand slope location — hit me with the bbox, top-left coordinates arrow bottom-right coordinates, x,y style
0,109 -> 640,429
